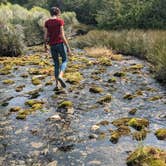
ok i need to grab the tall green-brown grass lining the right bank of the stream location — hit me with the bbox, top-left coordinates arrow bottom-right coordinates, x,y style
72,30 -> 166,82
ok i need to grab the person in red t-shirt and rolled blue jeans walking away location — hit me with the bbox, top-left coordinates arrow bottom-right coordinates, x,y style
44,7 -> 71,88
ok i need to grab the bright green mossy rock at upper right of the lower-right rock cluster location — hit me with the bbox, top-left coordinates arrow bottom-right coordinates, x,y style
128,118 -> 149,130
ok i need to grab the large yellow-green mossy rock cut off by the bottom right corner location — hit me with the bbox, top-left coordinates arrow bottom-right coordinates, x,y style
126,146 -> 166,166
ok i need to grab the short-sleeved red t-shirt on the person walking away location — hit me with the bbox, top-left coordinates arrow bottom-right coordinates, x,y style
45,18 -> 64,45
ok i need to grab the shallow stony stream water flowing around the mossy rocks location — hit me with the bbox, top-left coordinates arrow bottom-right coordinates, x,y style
0,47 -> 166,166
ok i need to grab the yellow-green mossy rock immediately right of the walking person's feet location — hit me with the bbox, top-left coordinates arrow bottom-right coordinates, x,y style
65,72 -> 83,84
